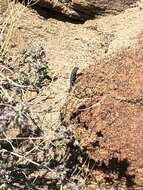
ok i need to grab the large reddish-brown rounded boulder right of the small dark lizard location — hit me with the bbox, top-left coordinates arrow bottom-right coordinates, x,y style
61,39 -> 143,189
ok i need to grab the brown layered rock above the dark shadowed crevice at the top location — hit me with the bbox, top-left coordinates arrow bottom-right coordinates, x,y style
38,0 -> 137,20
